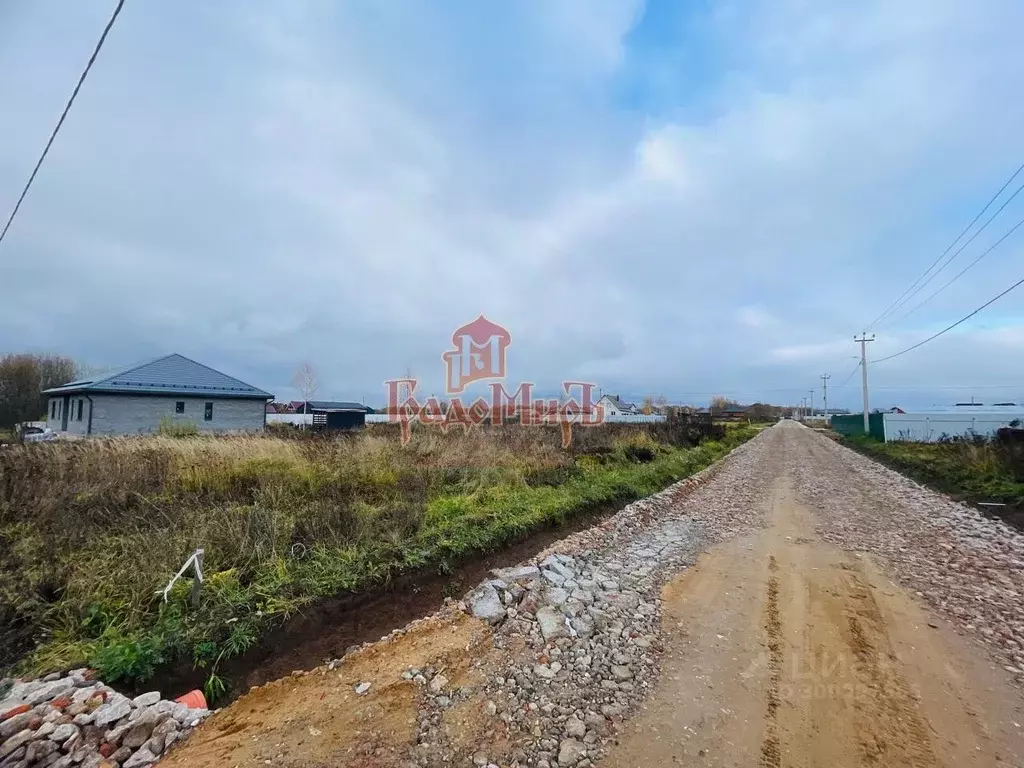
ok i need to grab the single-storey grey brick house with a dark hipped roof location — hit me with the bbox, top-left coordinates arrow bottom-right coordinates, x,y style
43,354 -> 273,435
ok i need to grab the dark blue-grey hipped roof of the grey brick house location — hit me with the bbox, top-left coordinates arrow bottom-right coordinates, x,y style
43,354 -> 273,400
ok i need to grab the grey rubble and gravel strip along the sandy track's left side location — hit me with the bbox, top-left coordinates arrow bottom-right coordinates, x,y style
407,434 -> 770,768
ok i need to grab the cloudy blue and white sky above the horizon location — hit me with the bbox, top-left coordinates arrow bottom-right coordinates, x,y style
0,0 -> 1024,409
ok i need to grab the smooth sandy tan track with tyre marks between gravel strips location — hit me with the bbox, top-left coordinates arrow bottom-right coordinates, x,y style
603,476 -> 1024,768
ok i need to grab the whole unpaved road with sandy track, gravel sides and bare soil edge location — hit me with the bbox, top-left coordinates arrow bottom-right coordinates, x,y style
159,424 -> 1024,768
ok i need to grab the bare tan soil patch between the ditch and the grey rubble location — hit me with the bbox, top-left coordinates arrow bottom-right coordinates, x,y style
161,612 -> 498,768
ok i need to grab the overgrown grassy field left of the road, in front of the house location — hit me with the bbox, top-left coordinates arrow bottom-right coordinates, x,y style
0,424 -> 755,695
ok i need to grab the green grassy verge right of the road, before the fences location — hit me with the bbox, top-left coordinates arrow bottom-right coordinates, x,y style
843,435 -> 1024,527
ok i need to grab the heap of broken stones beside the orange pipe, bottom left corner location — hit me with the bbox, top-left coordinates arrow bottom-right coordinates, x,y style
0,670 -> 210,768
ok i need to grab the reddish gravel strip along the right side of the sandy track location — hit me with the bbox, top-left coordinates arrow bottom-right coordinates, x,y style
786,428 -> 1024,682
